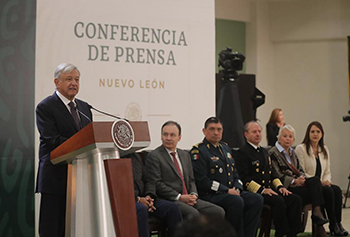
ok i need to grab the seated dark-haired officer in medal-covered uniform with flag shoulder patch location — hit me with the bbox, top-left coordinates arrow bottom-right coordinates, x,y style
191,117 -> 263,237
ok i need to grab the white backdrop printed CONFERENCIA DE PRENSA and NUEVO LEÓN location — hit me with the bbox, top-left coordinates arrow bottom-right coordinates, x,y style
36,0 -> 215,149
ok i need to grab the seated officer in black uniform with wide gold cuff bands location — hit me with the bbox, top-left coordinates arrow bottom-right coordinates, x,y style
236,121 -> 302,237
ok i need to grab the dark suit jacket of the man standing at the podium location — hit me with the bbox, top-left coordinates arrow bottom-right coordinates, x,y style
36,92 -> 92,195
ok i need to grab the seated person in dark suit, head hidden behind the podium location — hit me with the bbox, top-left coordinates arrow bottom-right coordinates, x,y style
125,153 -> 182,237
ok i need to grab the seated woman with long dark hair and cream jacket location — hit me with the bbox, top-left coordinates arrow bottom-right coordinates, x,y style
295,121 -> 349,236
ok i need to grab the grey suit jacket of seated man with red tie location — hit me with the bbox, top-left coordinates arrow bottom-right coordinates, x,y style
146,145 -> 197,201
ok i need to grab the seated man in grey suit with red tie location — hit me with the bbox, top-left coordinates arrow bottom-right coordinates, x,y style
146,121 -> 225,218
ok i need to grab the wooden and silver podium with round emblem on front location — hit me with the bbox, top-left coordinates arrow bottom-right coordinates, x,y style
50,122 -> 150,237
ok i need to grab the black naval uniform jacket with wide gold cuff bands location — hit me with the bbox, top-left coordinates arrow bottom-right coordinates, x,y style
235,143 -> 283,193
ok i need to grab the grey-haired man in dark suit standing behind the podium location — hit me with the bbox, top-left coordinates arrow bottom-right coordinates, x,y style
36,63 -> 92,237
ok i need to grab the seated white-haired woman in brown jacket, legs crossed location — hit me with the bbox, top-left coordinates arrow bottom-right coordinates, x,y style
269,125 -> 328,236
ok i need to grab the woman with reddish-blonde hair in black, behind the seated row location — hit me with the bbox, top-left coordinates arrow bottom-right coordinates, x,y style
266,109 -> 285,146
